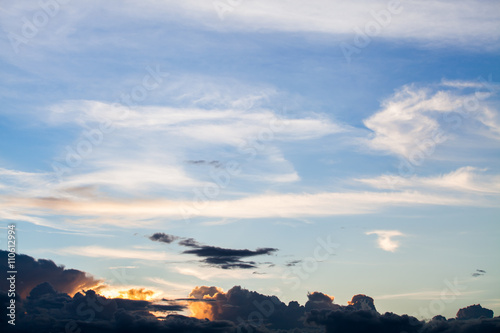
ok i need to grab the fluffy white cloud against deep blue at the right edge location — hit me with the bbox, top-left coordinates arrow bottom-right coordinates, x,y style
364,81 -> 500,161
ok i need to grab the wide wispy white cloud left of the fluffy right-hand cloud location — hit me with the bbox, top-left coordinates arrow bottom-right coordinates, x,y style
49,101 -> 344,146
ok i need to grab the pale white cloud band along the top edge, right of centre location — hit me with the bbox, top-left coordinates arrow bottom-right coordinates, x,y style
194,0 -> 500,46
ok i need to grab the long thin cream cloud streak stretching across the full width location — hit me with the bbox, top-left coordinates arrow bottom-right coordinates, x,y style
4,187 -> 488,227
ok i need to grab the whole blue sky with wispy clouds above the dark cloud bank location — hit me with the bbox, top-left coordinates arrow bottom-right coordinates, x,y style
0,0 -> 500,326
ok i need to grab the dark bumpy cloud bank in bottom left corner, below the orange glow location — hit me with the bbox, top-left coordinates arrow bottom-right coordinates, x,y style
0,283 -> 243,333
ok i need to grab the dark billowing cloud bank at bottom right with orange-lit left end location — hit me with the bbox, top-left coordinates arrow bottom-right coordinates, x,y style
190,286 -> 500,333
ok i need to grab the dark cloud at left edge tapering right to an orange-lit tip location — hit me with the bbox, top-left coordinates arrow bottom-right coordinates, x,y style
0,250 -> 100,298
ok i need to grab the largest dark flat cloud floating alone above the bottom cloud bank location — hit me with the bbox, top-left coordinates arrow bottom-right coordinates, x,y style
149,232 -> 278,269
